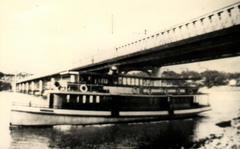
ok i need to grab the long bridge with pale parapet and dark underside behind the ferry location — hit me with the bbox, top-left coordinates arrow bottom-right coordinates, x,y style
17,2 -> 240,89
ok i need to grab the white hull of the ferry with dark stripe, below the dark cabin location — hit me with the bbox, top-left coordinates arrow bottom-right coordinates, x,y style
11,106 -> 210,126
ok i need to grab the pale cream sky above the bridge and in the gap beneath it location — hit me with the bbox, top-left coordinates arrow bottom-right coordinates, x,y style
0,0 -> 240,74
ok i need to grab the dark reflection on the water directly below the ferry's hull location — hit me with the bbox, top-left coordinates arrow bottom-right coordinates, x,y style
11,119 -> 195,149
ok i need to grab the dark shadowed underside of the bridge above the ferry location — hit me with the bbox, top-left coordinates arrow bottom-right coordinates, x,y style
71,25 -> 240,72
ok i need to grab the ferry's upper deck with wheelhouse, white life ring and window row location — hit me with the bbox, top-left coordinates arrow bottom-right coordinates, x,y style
61,72 -> 199,94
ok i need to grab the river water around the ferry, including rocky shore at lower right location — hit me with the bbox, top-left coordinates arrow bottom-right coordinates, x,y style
0,87 -> 240,149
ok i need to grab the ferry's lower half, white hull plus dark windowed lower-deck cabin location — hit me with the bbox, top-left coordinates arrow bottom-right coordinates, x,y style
11,92 -> 210,125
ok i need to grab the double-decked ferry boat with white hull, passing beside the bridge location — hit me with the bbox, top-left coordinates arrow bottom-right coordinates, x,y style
11,71 -> 210,126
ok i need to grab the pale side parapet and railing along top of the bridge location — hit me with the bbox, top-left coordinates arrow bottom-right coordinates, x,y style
81,2 -> 240,66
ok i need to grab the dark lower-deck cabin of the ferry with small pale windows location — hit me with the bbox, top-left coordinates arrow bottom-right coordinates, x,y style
49,92 -> 208,111
